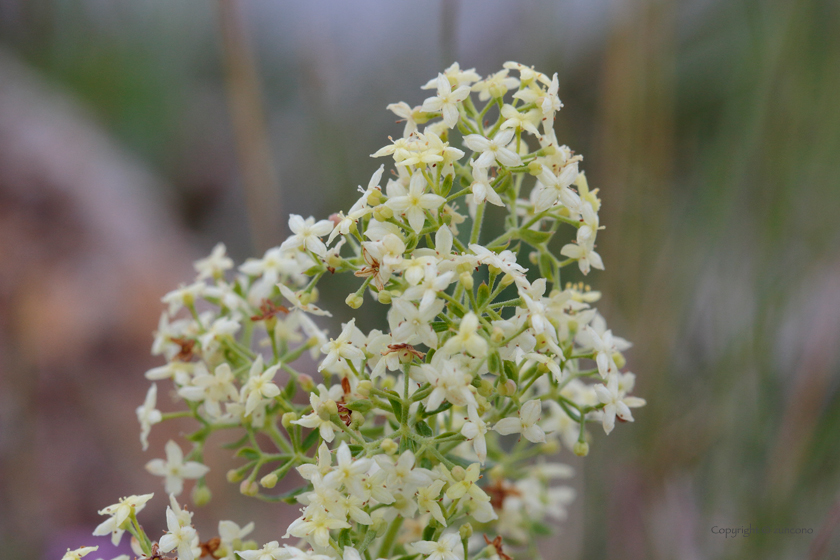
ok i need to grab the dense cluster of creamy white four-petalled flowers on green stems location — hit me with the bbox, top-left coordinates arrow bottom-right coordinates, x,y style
72,62 -> 644,560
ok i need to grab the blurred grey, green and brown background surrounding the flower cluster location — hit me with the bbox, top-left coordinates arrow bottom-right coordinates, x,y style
0,0 -> 840,560
